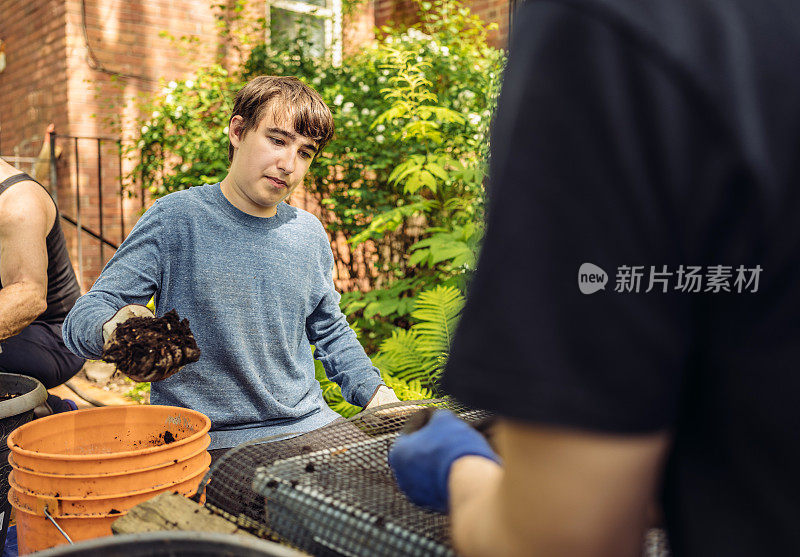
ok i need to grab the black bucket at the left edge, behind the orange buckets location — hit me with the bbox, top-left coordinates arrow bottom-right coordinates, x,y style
0,373 -> 47,548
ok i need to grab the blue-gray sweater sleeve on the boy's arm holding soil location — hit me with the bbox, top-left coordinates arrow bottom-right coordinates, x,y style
62,202 -> 165,358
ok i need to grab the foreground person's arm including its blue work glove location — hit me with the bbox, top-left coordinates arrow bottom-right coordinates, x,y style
389,410 -> 669,557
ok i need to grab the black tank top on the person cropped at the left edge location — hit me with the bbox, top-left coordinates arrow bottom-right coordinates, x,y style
0,173 -> 81,323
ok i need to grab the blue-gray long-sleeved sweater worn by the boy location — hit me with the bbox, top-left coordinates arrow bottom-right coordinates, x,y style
63,184 -> 382,448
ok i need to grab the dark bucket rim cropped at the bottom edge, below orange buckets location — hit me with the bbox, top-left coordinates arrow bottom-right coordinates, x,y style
29,530 -> 306,557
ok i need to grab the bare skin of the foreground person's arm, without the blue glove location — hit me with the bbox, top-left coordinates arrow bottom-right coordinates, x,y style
449,420 -> 669,557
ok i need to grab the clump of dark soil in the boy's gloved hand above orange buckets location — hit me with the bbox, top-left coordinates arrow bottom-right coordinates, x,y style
102,309 -> 200,382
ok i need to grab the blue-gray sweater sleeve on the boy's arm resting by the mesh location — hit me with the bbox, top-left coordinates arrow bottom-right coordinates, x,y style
306,233 -> 384,406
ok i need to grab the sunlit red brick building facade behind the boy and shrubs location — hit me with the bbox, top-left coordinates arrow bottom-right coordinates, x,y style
0,0 -> 509,290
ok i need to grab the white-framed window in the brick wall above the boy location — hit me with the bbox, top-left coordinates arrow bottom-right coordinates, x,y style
265,0 -> 342,66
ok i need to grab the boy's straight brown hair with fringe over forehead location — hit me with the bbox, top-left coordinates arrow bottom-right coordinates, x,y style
228,75 -> 334,162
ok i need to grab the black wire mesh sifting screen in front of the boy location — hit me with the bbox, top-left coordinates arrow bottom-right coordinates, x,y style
201,399 -> 488,557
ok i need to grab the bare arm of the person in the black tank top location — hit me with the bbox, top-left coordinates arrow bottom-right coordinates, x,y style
0,183 -> 48,341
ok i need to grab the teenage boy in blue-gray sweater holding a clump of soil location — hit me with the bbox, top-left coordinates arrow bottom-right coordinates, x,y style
64,76 -> 397,449
